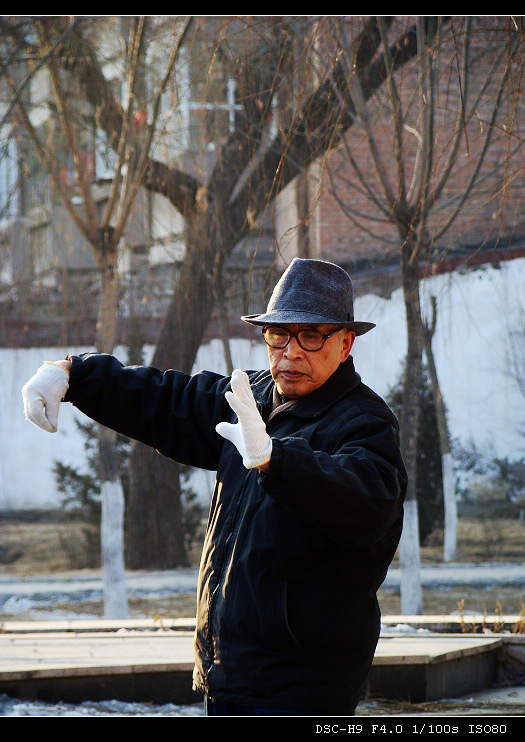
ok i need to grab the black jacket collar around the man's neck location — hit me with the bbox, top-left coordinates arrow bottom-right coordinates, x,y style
252,356 -> 361,417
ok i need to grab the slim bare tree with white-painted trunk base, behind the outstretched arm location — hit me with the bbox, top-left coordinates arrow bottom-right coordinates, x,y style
3,17 -> 187,618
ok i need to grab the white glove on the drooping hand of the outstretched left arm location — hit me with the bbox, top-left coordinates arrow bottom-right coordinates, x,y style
22,361 -> 69,433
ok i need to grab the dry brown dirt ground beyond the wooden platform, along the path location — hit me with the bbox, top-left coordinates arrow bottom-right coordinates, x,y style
0,516 -> 525,620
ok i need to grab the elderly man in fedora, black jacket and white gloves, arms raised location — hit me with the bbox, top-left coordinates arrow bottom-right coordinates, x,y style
23,259 -> 406,715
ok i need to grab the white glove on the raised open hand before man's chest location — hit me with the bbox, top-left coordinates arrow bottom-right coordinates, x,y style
215,369 -> 272,469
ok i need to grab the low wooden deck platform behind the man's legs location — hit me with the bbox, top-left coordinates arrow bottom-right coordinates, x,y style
0,617 -> 525,704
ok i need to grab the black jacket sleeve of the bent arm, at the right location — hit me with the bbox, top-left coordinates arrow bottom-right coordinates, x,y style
260,414 -> 406,547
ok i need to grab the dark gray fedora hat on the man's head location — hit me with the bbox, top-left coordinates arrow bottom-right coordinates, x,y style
241,258 -> 375,335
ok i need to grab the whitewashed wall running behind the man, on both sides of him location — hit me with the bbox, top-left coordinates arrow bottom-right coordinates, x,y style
0,259 -> 525,509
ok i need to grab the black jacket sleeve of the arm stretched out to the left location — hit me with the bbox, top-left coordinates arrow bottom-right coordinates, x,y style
64,353 -> 229,470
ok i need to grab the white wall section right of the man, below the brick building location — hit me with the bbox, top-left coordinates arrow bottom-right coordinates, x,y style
353,259 -> 525,458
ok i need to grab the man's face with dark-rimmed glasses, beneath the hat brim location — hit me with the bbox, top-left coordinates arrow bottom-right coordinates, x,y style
268,325 -> 355,399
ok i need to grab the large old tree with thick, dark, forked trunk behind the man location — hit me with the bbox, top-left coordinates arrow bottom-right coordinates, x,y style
1,16 -> 450,567
